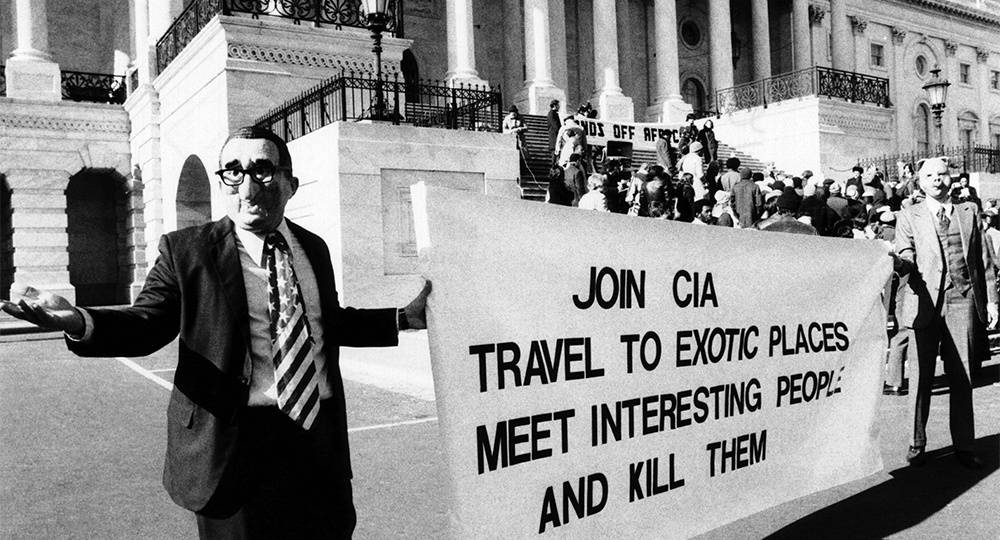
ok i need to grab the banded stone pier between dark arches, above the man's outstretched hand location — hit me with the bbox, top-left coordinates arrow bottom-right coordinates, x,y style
7,170 -> 76,302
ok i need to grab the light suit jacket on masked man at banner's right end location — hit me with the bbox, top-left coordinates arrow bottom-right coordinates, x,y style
895,202 -> 997,328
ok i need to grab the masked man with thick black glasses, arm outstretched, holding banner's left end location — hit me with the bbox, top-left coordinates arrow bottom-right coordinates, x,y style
0,127 -> 430,539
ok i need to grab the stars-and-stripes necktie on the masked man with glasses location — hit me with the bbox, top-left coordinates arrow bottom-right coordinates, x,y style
264,231 -> 319,429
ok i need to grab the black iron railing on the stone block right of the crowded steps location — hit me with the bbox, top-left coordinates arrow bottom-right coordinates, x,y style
715,66 -> 892,115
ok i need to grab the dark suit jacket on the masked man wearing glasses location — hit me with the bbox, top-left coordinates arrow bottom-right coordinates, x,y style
68,218 -> 398,512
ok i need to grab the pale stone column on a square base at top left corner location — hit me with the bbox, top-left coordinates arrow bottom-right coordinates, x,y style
6,0 -> 62,101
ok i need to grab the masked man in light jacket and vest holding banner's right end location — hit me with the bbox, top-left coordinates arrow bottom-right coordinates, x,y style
890,158 -> 997,469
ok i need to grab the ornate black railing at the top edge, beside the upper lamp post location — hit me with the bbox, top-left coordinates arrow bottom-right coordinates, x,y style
156,0 -> 403,73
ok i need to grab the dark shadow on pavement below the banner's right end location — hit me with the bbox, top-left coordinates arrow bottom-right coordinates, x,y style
767,435 -> 1000,540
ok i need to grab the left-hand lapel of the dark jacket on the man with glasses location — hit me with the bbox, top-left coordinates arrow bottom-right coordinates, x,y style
208,217 -> 250,351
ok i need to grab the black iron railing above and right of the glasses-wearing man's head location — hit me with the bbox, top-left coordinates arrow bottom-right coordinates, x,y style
254,73 -> 503,141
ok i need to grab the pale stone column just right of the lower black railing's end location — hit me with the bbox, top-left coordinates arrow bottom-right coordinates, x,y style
514,0 -> 567,115
